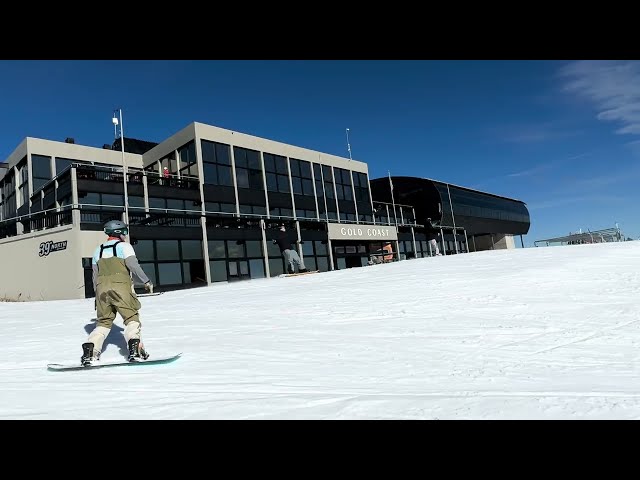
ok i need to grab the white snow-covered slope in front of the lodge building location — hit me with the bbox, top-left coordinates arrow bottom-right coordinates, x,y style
0,241 -> 640,419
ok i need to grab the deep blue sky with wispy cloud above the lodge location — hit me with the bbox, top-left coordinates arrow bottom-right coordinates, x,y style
0,60 -> 640,246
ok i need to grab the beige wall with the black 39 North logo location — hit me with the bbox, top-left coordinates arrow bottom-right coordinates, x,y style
0,225 -> 84,301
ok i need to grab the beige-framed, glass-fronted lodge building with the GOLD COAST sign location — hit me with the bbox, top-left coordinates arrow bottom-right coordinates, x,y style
0,123 -> 528,300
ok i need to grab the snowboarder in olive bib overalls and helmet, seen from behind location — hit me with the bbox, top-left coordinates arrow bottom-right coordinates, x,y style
80,220 -> 153,365
